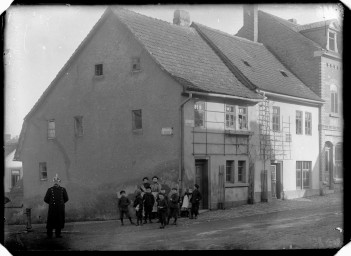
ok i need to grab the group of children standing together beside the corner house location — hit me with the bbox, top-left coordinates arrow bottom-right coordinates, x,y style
118,176 -> 202,229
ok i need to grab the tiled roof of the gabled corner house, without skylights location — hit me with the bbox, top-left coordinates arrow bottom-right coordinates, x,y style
112,8 -> 261,99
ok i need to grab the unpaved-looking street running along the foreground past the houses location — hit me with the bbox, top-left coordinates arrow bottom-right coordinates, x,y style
5,193 -> 343,252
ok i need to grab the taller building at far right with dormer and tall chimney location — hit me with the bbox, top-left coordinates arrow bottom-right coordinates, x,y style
237,5 -> 343,193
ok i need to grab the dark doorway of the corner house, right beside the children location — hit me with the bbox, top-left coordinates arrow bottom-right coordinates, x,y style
195,159 -> 208,209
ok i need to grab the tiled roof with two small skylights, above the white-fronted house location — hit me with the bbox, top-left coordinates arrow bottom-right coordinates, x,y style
195,23 -> 321,100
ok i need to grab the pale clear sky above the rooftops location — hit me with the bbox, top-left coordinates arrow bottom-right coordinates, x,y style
4,4 -> 342,137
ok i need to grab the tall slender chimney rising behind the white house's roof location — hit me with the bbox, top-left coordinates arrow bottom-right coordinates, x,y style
243,4 -> 258,42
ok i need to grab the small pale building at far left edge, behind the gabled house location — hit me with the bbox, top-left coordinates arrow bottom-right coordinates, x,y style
4,150 -> 23,193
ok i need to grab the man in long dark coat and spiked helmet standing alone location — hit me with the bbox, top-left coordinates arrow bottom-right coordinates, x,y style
44,173 -> 68,238
